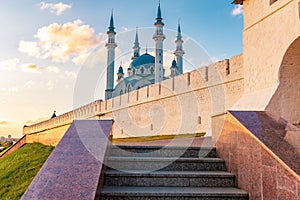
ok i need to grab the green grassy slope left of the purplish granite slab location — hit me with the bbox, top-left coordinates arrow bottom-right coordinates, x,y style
0,143 -> 54,200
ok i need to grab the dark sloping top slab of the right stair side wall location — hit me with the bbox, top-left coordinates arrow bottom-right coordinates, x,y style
229,111 -> 300,175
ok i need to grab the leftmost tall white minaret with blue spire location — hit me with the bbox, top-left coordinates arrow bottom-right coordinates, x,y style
105,11 -> 117,99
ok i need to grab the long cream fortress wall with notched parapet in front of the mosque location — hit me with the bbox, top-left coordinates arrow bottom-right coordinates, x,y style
23,55 -> 243,143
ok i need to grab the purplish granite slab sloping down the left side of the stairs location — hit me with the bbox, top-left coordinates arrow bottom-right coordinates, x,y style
22,120 -> 112,200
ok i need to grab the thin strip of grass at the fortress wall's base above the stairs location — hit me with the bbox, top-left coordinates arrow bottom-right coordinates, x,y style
112,133 -> 205,143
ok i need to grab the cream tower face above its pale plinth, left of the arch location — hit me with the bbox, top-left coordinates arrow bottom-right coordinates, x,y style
241,0 -> 300,94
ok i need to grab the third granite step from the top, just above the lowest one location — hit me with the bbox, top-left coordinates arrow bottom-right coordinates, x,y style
104,170 -> 235,187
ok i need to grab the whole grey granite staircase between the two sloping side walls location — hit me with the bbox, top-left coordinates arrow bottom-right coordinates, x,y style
100,146 -> 249,200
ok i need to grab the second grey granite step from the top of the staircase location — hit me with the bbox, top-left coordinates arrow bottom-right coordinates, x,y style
107,156 -> 226,172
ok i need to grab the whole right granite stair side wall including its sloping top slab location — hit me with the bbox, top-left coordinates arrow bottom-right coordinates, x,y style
213,111 -> 300,200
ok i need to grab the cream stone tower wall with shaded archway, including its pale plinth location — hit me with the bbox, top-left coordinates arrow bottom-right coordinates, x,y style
232,0 -> 300,123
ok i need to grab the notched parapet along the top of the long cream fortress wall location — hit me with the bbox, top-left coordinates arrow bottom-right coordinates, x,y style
23,54 -> 243,137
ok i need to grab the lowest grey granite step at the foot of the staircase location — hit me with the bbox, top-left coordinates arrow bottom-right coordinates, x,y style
101,186 -> 249,200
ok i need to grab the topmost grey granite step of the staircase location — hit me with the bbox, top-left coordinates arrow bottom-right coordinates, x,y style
109,145 -> 217,158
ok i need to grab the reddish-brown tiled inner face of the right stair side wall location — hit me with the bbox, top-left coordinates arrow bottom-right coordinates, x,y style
216,111 -> 300,200
